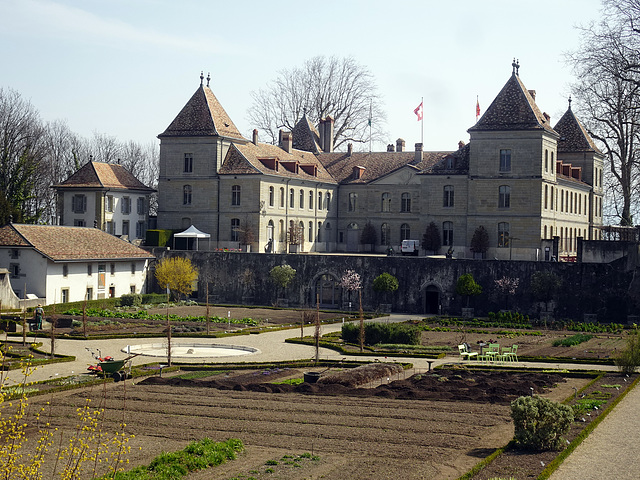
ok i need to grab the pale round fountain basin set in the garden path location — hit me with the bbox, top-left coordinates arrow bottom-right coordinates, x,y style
122,343 -> 260,359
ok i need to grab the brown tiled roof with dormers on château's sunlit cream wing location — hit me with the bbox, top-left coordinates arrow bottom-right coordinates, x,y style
218,142 -> 336,183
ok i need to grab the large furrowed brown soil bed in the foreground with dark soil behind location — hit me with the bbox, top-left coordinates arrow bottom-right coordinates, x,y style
26,369 -> 620,479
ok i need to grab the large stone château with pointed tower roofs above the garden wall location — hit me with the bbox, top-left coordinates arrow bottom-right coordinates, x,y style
158,62 -> 603,260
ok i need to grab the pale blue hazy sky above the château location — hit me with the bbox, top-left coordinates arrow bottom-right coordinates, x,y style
0,0 -> 601,151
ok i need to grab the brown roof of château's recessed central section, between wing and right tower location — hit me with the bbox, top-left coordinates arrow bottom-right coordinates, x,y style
318,152 -> 452,184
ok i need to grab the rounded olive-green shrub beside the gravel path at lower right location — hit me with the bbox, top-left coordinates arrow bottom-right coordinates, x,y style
511,396 -> 573,451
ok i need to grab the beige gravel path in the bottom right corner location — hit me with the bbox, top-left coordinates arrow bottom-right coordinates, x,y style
551,378 -> 640,480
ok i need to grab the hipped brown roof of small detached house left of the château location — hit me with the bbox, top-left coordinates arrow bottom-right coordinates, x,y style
53,162 -> 155,192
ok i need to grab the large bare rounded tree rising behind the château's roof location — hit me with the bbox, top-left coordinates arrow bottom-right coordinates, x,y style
248,56 -> 386,149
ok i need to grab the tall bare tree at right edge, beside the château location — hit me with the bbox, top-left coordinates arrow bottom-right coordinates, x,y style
568,0 -> 640,225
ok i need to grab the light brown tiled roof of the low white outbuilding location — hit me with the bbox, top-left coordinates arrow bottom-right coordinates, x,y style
0,223 -> 154,261
